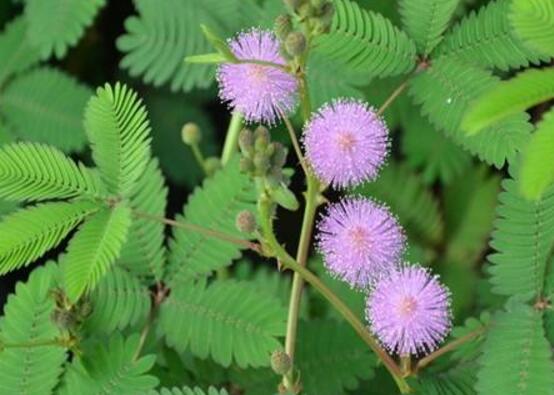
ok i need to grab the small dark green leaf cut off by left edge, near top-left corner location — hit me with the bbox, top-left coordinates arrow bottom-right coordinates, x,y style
0,17 -> 40,87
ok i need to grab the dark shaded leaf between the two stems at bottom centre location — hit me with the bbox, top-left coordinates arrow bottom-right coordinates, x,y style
295,320 -> 375,395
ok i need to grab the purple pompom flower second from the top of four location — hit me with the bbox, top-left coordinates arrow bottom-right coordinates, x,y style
304,99 -> 389,188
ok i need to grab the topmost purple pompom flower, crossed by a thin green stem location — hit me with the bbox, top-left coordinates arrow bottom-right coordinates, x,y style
217,29 -> 298,124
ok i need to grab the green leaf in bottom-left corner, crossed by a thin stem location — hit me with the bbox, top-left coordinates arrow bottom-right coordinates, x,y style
0,262 -> 66,395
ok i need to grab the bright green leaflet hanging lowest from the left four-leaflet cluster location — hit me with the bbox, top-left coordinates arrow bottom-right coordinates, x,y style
62,204 -> 131,301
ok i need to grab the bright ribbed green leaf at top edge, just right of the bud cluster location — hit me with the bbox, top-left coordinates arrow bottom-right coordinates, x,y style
314,0 -> 416,77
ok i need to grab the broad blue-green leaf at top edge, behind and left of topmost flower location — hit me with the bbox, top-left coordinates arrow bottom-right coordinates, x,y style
117,0 -> 258,91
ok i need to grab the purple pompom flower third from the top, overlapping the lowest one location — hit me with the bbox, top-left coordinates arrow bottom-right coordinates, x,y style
318,197 -> 405,288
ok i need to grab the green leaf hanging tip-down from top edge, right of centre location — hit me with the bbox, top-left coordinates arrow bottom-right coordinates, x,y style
399,0 -> 459,55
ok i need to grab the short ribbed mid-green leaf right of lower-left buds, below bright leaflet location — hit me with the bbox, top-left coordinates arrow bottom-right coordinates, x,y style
87,266 -> 151,333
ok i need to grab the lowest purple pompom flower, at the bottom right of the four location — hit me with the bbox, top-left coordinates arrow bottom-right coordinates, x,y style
366,266 -> 451,355
